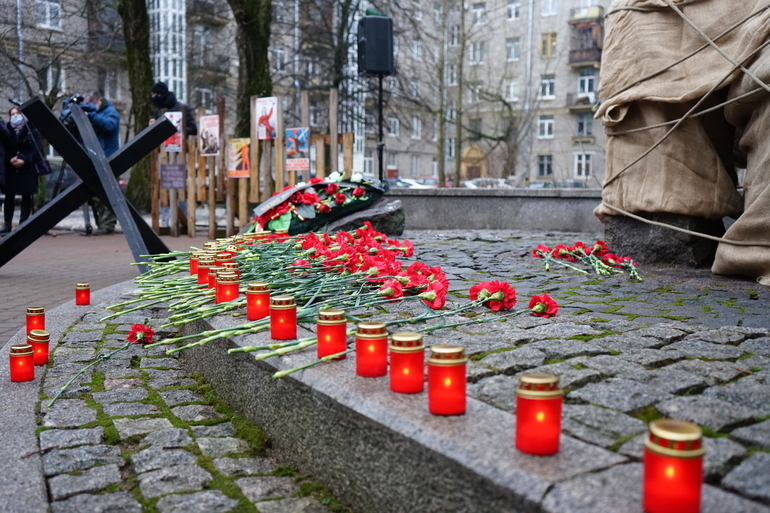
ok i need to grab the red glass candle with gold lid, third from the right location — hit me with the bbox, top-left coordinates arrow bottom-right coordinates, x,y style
428,344 -> 468,415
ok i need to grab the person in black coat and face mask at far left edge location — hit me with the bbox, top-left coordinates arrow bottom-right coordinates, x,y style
0,107 -> 43,234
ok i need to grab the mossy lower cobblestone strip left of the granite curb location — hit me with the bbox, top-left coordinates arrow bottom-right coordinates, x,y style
38,308 -> 346,513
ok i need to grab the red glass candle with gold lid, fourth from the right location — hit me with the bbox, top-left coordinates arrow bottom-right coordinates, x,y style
390,332 -> 425,394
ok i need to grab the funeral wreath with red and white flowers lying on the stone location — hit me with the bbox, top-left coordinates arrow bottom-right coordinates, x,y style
248,171 -> 385,235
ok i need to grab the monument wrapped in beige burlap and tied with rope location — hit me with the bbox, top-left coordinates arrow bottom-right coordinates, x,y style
594,0 -> 770,279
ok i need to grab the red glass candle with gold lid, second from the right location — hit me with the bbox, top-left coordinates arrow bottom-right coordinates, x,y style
516,374 -> 564,456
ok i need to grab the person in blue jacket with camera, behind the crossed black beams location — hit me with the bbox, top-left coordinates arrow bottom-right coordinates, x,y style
80,91 -> 120,235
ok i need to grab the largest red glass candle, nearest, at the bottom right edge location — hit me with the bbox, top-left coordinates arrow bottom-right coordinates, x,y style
642,419 -> 705,513
